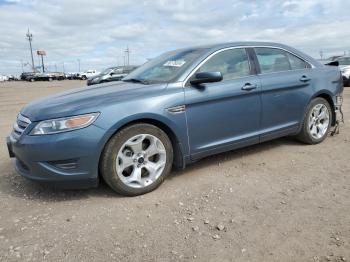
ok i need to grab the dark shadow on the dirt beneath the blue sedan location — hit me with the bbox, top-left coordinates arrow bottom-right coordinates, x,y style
0,137 -> 302,202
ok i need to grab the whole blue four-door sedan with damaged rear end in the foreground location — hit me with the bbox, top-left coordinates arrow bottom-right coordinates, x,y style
7,42 -> 343,196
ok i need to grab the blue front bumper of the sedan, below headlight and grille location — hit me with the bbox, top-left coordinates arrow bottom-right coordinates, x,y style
6,125 -> 106,189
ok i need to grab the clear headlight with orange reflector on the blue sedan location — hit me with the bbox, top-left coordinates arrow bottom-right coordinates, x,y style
30,113 -> 100,135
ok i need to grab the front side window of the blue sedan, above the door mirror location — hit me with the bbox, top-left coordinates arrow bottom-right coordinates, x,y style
197,48 -> 250,80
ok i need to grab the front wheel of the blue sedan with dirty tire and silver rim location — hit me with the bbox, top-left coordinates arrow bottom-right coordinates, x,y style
100,123 -> 173,196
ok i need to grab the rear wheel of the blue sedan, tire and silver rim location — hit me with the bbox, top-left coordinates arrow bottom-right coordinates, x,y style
297,97 -> 333,145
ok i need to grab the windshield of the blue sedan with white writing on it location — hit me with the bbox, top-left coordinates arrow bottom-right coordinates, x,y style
123,48 -> 207,83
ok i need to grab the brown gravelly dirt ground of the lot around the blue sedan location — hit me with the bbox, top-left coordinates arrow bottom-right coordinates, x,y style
0,81 -> 350,261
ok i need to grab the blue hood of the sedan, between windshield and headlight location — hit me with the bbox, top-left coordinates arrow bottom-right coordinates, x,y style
21,82 -> 166,121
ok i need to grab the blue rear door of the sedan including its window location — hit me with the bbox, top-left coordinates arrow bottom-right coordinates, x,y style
254,47 -> 312,141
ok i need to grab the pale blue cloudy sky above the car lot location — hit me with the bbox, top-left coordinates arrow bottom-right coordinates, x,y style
0,0 -> 350,74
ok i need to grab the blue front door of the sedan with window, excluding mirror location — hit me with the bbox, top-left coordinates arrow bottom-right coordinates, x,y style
185,48 -> 261,160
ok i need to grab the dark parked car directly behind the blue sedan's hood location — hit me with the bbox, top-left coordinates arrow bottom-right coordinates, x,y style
87,66 -> 137,86
